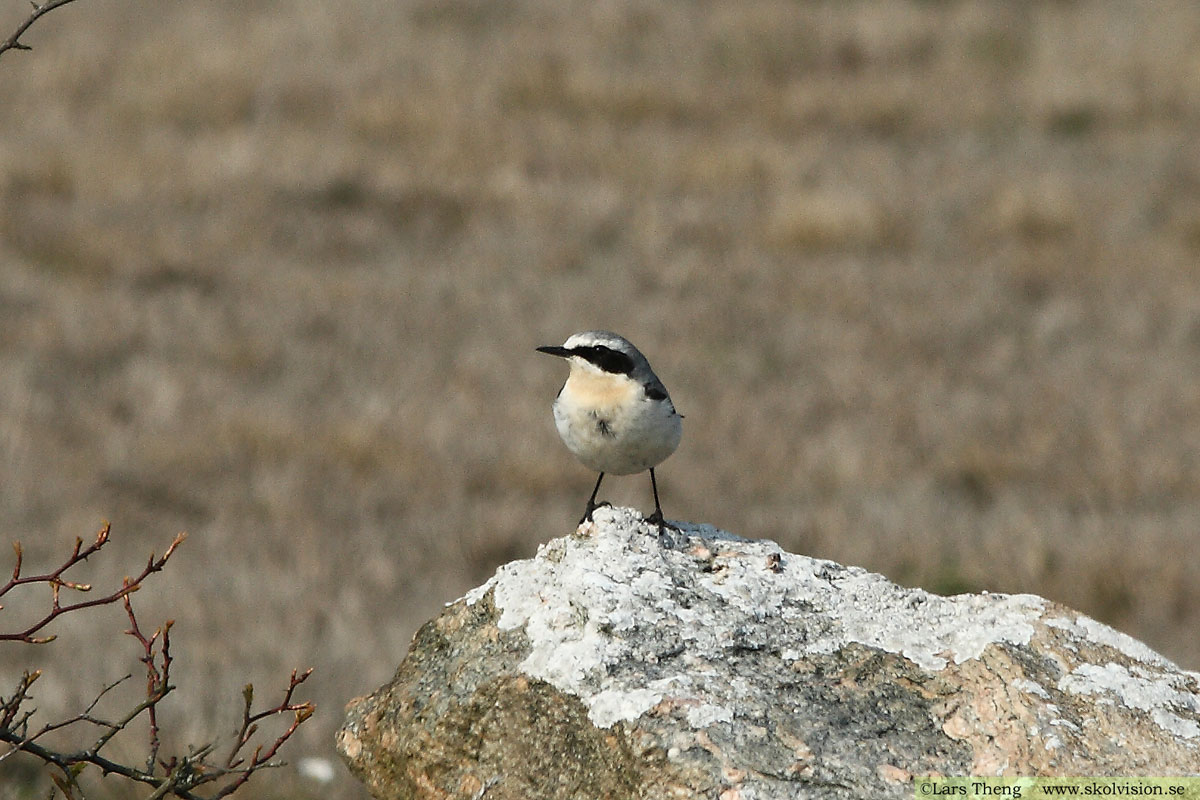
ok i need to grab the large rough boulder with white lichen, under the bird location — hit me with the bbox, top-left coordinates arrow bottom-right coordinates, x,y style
338,509 -> 1200,800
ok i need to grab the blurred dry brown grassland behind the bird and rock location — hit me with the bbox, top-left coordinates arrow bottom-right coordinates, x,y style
0,0 -> 1200,799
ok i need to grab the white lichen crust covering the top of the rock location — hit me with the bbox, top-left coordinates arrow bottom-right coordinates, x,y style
466,509 -> 1198,738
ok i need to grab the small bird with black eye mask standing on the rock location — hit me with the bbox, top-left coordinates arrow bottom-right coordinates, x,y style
538,331 -> 683,529
